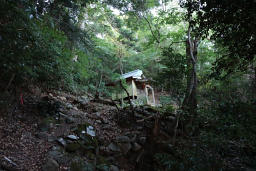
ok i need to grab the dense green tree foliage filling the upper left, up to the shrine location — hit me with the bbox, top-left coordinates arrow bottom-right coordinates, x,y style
0,1 -> 122,92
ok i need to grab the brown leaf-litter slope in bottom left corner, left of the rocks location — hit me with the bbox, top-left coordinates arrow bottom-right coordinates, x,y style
0,113 -> 51,170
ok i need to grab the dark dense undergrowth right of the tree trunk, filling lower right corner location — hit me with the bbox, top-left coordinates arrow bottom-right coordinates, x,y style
154,77 -> 256,170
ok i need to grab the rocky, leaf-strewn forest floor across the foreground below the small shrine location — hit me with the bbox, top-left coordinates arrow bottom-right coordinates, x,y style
0,92 -> 254,171
